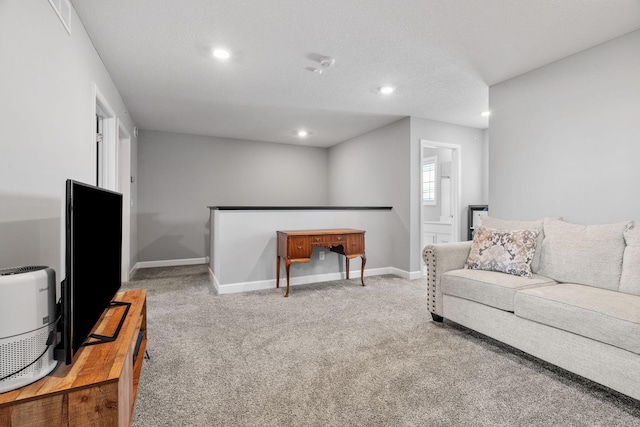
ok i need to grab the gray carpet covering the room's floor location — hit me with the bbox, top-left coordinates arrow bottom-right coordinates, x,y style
123,266 -> 640,426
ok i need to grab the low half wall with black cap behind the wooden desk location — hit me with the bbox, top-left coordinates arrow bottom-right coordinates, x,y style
209,209 -> 390,293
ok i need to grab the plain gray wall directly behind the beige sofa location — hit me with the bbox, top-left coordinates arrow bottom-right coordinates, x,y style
489,31 -> 640,223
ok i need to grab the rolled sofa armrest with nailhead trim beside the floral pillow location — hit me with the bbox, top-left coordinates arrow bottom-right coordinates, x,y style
422,241 -> 471,320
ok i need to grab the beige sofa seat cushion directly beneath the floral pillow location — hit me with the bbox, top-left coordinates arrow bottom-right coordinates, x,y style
440,269 -> 556,311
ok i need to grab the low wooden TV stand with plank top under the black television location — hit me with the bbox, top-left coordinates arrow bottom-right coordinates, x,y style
0,290 -> 147,426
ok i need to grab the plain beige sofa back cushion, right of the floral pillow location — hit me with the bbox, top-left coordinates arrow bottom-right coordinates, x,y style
538,218 -> 632,290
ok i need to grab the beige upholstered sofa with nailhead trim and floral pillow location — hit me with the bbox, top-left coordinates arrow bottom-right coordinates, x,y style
423,217 -> 640,399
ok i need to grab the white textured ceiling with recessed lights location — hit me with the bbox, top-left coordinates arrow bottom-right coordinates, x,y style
72,0 -> 640,147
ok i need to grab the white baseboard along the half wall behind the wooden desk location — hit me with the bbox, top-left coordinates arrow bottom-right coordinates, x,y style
209,267 -> 410,295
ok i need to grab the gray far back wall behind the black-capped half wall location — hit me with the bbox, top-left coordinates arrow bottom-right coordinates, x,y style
137,131 -> 328,261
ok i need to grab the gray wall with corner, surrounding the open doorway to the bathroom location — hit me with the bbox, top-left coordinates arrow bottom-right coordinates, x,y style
329,117 -> 486,275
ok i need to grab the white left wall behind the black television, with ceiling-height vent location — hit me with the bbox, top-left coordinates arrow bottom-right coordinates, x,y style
0,0 -> 136,282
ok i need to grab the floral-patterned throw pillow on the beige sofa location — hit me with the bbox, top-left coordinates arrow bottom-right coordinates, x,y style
464,226 -> 540,277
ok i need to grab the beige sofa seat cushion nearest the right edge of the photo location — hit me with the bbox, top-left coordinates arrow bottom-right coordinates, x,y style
514,283 -> 640,354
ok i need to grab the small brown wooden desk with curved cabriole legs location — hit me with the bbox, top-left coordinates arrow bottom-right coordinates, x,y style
276,228 -> 367,297
